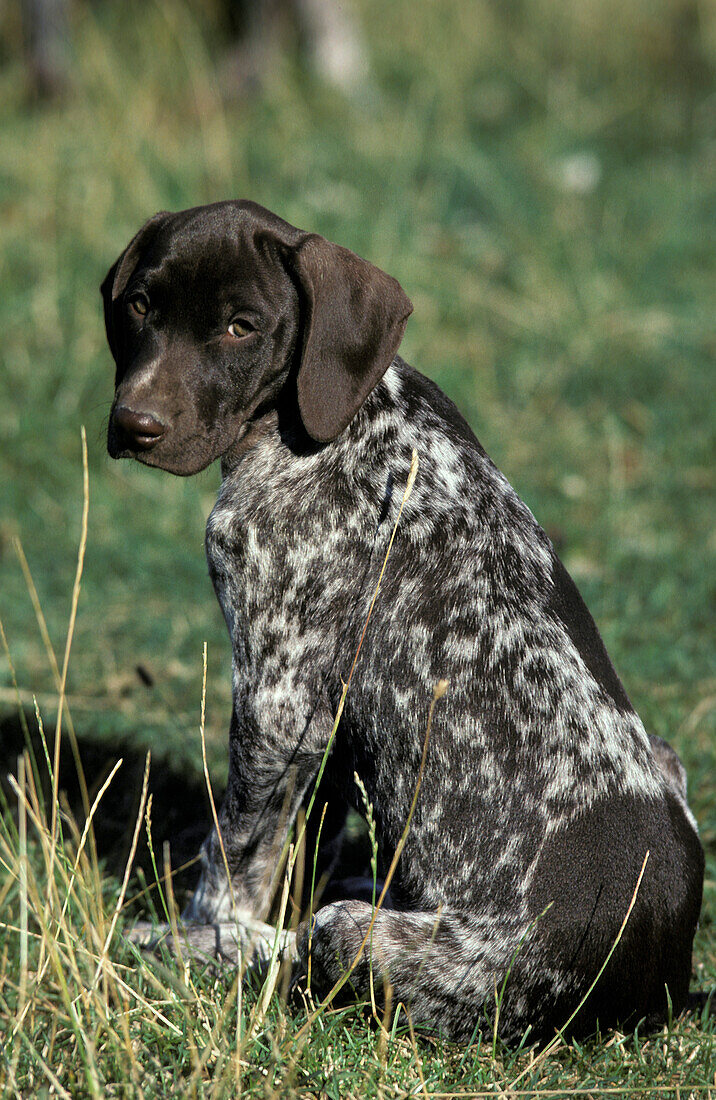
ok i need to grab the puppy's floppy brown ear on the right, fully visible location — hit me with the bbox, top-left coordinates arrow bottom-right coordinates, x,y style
295,235 -> 412,442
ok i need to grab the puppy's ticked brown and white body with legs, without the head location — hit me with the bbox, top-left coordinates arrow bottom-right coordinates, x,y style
102,202 -> 703,1041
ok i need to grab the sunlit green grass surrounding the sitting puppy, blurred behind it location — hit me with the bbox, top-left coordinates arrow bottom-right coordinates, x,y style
0,0 -> 716,1097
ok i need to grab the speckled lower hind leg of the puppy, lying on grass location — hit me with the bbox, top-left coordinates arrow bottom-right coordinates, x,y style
297,901 -> 524,1042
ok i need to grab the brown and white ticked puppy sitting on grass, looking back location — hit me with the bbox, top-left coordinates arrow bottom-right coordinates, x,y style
102,201 -> 703,1041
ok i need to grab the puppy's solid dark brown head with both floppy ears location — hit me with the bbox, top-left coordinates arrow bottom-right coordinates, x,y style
102,202 -> 412,474
